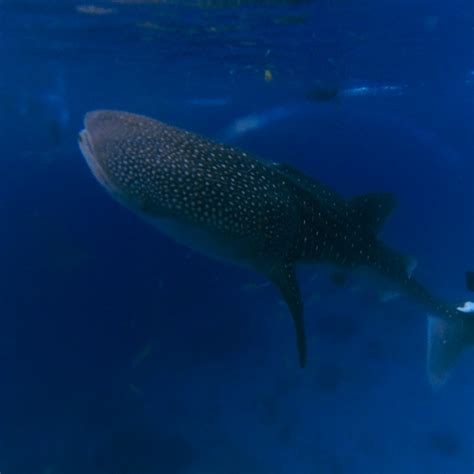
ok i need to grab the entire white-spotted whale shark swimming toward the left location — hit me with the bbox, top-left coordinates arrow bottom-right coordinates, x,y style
79,110 -> 474,385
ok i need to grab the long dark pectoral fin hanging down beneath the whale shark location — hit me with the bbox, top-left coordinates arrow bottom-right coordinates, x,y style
269,263 -> 307,367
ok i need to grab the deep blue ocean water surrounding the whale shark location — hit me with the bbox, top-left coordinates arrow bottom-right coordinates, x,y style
0,0 -> 474,474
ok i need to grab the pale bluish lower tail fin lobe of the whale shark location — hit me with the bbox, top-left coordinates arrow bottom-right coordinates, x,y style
427,315 -> 474,387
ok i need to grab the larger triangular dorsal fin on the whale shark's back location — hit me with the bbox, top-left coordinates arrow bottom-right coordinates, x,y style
349,193 -> 397,234
